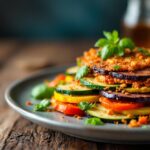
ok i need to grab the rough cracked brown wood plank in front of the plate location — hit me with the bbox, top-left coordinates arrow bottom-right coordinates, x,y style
3,118 -> 97,150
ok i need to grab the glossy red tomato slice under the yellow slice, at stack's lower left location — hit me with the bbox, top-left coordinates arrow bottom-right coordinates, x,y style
52,101 -> 85,116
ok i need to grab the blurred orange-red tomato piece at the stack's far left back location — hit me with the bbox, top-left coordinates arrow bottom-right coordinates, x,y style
48,74 -> 66,87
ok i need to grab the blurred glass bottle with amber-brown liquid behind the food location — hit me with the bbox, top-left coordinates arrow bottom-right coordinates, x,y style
123,0 -> 150,48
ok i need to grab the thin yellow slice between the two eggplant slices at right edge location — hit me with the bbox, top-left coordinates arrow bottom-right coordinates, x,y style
124,87 -> 150,93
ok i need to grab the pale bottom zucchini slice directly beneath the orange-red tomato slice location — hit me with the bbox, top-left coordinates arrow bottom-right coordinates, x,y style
87,104 -> 131,120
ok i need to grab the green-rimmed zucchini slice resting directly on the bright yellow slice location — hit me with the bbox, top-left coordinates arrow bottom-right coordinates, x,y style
56,82 -> 99,95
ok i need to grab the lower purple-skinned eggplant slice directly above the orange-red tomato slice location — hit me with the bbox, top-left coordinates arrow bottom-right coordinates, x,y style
100,91 -> 150,102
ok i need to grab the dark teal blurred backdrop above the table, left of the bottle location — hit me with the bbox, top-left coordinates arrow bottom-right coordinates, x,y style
0,0 -> 127,40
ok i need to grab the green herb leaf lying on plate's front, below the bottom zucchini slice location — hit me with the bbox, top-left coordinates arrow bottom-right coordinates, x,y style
85,117 -> 104,125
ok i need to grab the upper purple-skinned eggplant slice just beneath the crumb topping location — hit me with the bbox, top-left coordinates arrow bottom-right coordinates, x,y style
92,66 -> 150,81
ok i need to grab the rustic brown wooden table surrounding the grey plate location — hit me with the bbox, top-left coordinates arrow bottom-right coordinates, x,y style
0,41 -> 150,150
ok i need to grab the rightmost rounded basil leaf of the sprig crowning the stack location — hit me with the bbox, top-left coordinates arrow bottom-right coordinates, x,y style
119,38 -> 135,50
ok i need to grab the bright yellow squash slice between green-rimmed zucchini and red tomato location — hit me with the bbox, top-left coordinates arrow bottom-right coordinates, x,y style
54,91 -> 100,104
